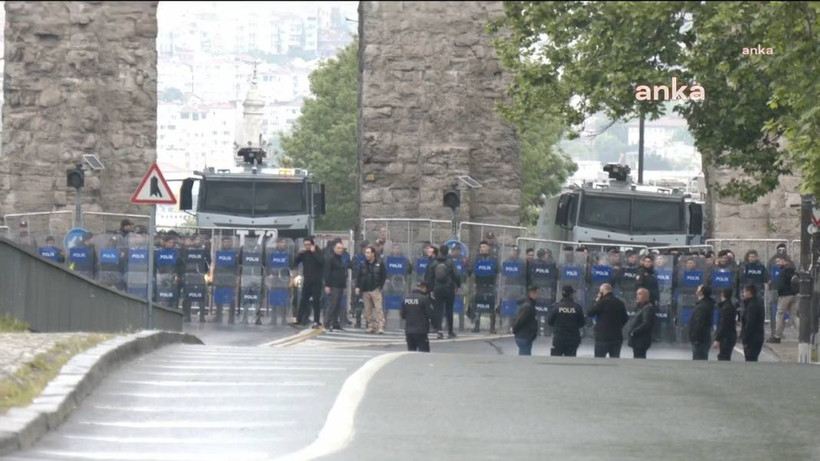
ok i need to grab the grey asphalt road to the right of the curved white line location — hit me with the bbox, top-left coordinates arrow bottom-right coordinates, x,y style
321,353 -> 820,461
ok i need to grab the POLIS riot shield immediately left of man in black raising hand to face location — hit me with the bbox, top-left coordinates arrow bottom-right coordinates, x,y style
265,238 -> 295,325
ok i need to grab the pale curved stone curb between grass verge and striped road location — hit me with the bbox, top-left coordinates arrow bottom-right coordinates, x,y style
0,330 -> 203,456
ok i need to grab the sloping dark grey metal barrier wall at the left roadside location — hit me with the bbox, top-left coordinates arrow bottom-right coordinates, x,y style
0,235 -> 182,333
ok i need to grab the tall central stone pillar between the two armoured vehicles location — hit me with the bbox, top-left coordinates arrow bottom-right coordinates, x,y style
358,1 -> 521,230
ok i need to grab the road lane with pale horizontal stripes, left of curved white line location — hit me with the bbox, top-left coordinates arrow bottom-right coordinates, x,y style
4,346 -> 374,461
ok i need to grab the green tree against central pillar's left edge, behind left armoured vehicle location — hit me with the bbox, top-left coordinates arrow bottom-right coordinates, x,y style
281,40 -> 358,230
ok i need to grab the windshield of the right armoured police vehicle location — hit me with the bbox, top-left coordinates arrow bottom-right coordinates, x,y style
578,195 -> 683,233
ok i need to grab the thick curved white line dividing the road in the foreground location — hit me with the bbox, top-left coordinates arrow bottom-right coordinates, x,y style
270,352 -> 410,461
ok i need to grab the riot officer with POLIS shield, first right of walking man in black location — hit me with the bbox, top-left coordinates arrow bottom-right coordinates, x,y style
470,245 -> 500,334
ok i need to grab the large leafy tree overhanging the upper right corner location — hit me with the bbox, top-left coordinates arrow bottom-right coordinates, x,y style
488,1 -> 820,202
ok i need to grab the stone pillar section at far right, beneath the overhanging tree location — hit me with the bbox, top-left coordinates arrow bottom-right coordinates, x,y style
705,167 -> 800,240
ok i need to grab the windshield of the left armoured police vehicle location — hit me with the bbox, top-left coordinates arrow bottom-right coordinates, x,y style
199,180 -> 307,216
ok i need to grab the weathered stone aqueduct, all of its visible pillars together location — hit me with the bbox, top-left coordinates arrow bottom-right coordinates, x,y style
0,1 -> 799,238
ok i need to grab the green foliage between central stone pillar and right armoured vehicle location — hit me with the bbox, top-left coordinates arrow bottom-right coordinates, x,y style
519,114 -> 578,226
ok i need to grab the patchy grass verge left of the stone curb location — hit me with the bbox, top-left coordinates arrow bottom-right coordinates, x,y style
0,334 -> 114,414
